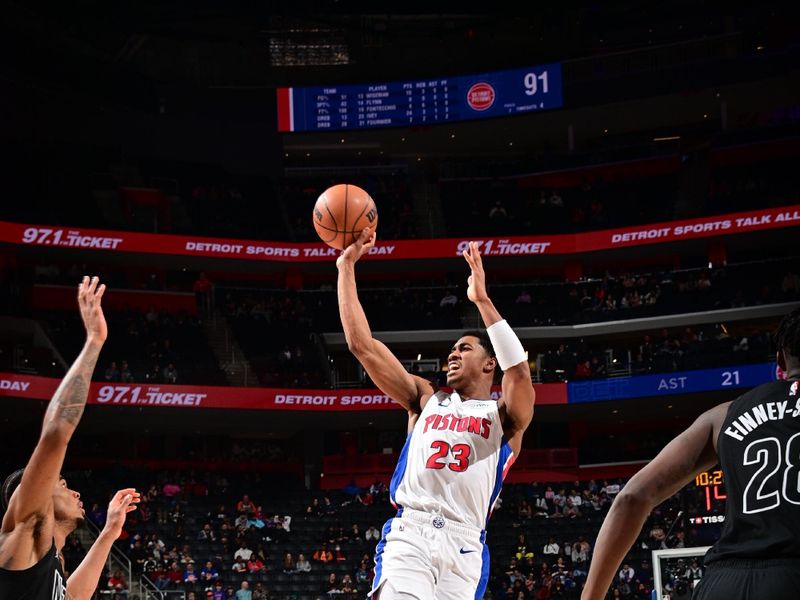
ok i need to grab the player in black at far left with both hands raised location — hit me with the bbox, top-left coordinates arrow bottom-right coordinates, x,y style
0,277 -> 139,600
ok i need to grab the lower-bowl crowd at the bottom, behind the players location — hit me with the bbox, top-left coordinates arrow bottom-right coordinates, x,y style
64,466 -> 718,600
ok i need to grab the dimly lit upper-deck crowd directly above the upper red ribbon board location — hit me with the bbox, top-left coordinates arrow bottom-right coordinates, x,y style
4,129 -> 800,242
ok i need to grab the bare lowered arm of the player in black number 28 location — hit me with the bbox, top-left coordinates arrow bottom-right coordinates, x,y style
581,403 -> 729,600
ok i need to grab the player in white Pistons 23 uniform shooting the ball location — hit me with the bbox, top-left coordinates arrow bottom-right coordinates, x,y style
336,228 -> 535,600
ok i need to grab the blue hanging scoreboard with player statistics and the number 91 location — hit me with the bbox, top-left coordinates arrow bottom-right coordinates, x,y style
278,63 -> 563,132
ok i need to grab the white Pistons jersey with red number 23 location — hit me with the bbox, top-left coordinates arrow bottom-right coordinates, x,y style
390,392 -> 514,530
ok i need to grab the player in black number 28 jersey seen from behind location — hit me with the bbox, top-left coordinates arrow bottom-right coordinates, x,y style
581,309 -> 800,600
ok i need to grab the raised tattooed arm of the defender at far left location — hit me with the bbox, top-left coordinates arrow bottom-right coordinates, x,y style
4,277 -> 108,528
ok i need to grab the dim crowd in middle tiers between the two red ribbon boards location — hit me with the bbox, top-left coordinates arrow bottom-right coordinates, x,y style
2,258 -> 800,388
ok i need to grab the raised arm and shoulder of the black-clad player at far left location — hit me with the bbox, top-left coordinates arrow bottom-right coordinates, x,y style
2,277 -> 108,569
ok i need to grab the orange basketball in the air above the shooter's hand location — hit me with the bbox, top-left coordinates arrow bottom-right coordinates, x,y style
311,183 -> 378,250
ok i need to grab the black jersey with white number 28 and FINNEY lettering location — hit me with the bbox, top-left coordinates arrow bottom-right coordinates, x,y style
706,381 -> 800,564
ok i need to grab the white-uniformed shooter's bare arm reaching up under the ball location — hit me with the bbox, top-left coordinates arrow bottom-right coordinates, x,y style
336,227 -> 435,413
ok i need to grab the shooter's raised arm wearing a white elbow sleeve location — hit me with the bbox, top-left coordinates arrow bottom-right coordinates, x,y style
463,242 -> 536,446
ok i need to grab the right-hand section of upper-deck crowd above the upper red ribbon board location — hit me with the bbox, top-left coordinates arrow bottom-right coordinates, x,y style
440,155 -> 800,237
